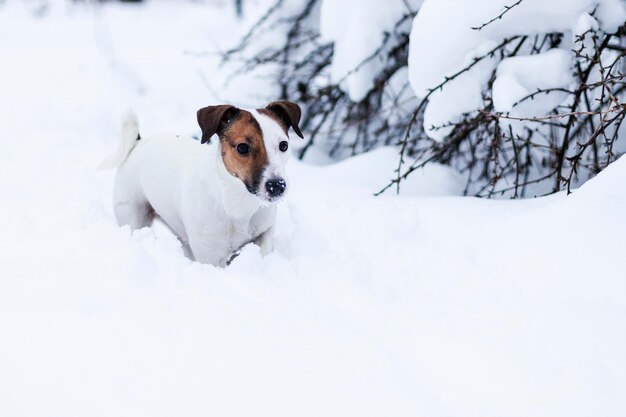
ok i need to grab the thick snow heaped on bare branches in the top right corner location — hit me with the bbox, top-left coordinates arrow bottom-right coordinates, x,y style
409,0 -> 626,140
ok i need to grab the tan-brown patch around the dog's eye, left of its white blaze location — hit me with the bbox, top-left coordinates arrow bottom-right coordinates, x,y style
218,110 -> 268,194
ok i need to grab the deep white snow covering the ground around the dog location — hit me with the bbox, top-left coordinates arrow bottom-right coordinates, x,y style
0,0 -> 626,417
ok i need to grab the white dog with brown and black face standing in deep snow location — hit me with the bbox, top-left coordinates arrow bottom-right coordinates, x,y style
102,101 -> 303,267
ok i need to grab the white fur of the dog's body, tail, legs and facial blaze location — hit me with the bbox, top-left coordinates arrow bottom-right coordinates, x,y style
105,110 -> 288,266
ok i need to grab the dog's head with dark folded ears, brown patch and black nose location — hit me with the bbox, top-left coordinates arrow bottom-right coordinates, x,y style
198,101 -> 303,201
